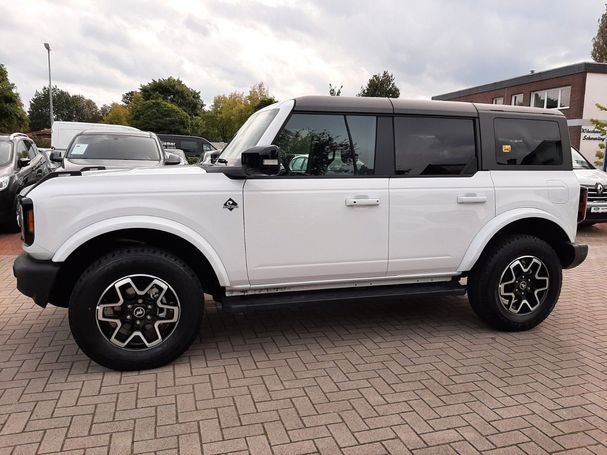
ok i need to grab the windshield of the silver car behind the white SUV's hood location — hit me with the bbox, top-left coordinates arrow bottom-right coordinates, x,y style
67,134 -> 160,161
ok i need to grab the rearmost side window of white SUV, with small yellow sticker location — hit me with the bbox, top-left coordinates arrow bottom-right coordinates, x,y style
494,118 -> 563,166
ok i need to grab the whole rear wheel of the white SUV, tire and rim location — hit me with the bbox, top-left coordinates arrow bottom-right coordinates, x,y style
468,234 -> 562,331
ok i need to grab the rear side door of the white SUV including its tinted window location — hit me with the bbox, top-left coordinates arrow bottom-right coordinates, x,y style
388,116 -> 495,276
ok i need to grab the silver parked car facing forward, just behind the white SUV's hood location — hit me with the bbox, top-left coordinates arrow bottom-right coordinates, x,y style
51,131 -> 181,171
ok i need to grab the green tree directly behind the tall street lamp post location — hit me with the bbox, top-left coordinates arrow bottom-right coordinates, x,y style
28,86 -> 101,131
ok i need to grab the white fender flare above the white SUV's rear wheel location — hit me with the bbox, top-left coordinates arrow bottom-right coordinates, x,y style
457,208 -> 575,273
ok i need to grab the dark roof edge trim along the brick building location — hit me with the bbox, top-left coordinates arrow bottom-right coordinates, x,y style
432,62 -> 607,100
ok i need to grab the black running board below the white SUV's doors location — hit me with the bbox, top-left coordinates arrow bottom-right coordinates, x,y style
222,281 -> 466,312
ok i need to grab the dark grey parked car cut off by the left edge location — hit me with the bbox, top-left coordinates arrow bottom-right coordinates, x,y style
0,133 -> 50,231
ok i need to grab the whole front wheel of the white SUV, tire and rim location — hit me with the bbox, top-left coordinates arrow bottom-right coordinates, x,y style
69,247 -> 204,370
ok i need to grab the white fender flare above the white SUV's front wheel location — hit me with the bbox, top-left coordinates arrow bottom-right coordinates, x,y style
52,216 -> 229,286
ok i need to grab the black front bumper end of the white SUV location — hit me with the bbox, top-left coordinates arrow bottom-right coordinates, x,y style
13,253 -> 61,308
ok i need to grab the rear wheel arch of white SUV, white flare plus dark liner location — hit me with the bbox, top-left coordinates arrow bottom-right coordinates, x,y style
458,211 -> 573,273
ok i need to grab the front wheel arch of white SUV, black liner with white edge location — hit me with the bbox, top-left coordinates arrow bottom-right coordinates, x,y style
49,227 -> 228,306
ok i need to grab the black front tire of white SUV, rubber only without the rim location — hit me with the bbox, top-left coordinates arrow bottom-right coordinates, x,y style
69,247 -> 204,371
